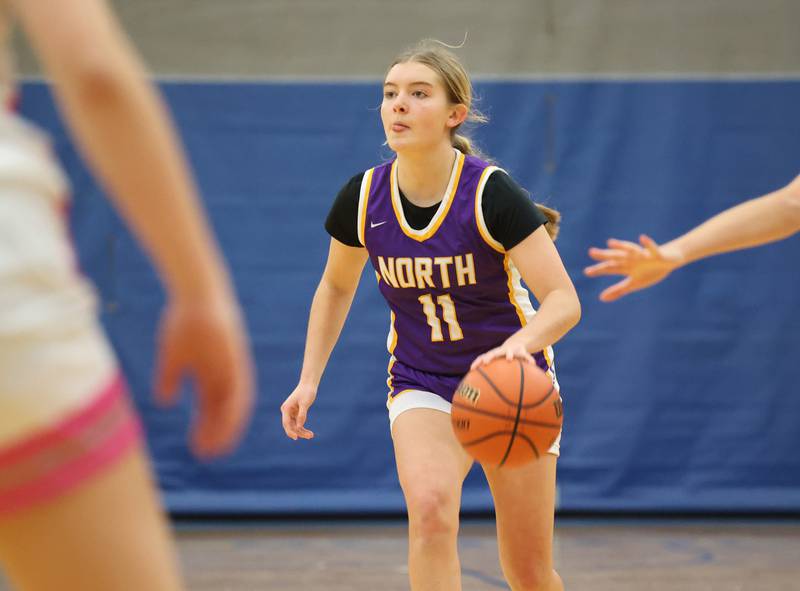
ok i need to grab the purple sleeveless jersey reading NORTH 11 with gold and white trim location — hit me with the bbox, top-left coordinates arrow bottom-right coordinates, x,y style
358,151 -> 552,386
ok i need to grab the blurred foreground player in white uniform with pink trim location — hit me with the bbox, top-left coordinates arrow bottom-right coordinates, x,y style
0,0 -> 253,591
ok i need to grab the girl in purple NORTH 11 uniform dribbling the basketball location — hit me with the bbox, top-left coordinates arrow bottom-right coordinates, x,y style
281,42 -> 580,591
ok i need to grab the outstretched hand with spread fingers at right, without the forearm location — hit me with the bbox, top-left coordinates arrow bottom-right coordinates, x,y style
584,234 -> 681,302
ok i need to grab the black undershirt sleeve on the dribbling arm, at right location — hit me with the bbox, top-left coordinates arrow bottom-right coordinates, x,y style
481,170 -> 547,250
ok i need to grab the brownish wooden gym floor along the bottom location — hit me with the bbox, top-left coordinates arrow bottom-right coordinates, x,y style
0,518 -> 800,591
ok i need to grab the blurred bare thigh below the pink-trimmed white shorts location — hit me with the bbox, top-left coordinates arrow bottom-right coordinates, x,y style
0,447 -> 183,591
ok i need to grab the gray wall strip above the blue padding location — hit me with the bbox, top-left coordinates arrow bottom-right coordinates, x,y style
12,0 -> 800,78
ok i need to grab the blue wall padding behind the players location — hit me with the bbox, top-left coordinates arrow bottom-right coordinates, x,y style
18,80 -> 800,514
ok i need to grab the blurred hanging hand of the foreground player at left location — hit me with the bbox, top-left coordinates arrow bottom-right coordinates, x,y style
156,297 -> 254,458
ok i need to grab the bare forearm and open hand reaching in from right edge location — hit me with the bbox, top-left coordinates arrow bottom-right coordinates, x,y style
585,171 -> 800,302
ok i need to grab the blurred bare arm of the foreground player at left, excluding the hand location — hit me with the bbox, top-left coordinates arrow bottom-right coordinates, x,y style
15,0 -> 228,300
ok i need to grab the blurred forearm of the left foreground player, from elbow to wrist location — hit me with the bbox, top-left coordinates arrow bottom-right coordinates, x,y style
54,51 -> 224,298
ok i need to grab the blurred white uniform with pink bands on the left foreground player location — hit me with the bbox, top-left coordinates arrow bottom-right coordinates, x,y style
0,0 -> 141,517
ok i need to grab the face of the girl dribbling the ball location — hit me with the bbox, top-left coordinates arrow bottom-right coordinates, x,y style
381,62 -> 467,153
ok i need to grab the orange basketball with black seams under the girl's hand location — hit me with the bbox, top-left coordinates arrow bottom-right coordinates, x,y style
450,359 -> 562,467
